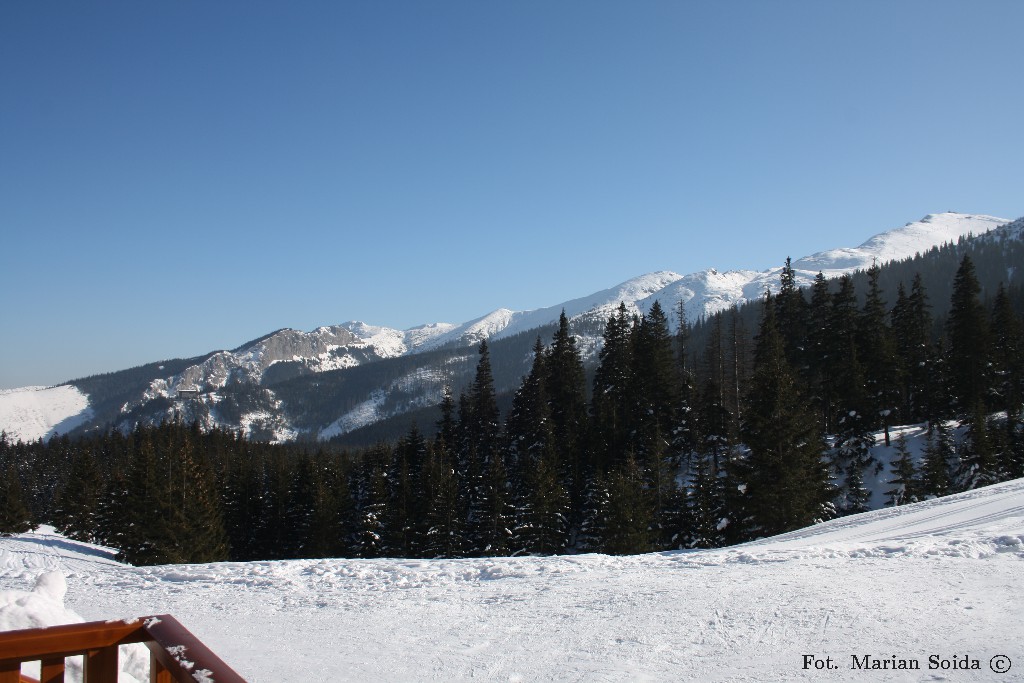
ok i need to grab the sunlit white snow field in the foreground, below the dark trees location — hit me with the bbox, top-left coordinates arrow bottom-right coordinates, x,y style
0,479 -> 1024,681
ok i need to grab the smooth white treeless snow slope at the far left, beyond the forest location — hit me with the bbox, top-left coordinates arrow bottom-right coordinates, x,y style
0,385 -> 92,441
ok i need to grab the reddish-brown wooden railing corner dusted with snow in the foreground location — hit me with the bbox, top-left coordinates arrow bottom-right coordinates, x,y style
0,614 -> 245,683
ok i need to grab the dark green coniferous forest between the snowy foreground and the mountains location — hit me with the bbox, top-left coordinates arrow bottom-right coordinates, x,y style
0,256 -> 1024,564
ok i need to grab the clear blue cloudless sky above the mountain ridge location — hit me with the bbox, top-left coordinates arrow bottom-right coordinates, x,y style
0,0 -> 1024,387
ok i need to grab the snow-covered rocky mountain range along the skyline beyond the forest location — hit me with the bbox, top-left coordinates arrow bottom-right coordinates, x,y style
0,213 -> 1007,440
